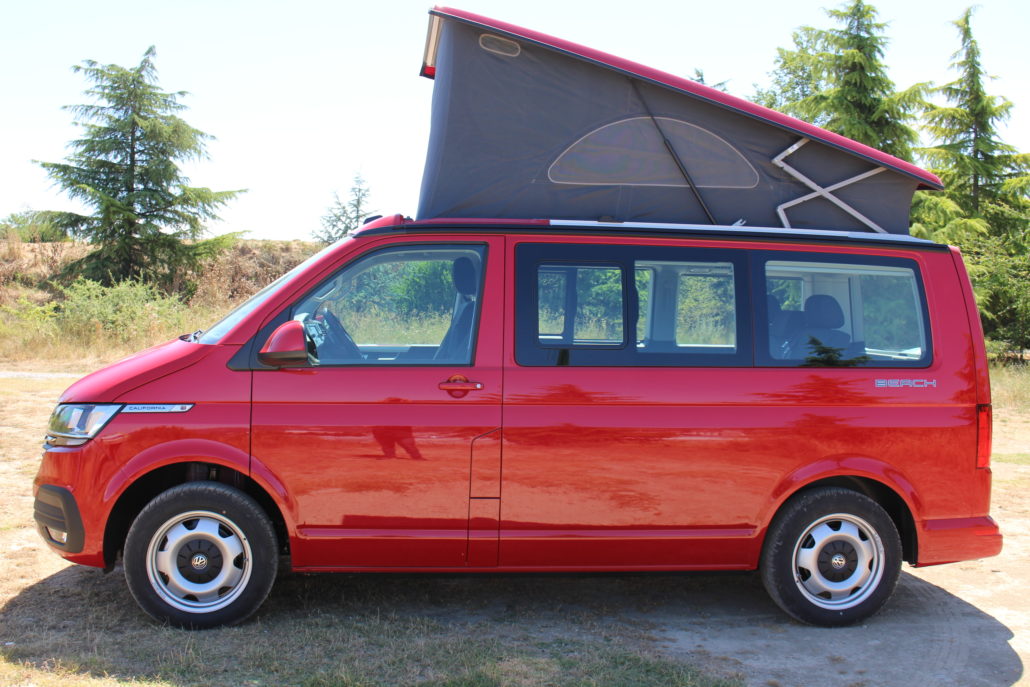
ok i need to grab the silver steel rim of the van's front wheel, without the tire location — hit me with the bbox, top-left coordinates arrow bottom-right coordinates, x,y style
146,511 -> 251,613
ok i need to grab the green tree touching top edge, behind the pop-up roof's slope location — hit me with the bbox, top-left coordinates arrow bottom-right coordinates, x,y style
757,0 -> 929,160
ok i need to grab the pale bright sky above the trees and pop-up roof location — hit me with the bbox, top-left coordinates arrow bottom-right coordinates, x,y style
0,0 -> 1030,239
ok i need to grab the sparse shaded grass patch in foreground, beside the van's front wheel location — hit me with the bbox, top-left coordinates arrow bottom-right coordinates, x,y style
0,580 -> 736,687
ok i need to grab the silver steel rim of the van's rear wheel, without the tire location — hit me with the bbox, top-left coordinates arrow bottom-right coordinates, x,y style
793,513 -> 884,610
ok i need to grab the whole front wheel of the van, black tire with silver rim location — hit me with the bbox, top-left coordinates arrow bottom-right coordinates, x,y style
123,482 -> 278,629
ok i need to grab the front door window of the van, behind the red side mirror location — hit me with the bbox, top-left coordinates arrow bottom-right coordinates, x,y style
293,245 -> 485,366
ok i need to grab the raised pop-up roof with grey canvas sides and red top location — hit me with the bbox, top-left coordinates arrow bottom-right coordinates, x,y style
418,7 -> 941,234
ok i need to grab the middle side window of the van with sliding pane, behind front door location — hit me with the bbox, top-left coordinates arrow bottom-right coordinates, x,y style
516,244 -> 752,367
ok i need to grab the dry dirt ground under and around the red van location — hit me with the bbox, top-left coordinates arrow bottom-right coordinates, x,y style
0,371 -> 1030,687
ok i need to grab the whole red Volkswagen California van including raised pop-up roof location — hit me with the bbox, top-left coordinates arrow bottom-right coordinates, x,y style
35,8 -> 1001,627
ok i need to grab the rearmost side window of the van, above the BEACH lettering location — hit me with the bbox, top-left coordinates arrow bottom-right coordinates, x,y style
757,253 -> 931,367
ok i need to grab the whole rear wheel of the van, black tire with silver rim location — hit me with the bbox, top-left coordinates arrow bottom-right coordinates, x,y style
761,487 -> 901,627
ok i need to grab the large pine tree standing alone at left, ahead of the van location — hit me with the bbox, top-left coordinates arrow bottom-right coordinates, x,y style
39,46 -> 241,285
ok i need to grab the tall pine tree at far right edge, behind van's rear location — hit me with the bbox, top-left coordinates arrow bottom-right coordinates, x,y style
912,8 -> 1030,351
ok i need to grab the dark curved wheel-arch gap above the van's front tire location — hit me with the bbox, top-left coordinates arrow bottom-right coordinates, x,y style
104,460 -> 289,570
